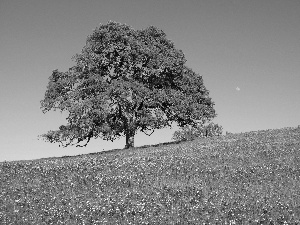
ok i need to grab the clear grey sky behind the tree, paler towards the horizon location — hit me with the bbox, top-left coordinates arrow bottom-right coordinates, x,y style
0,0 -> 300,162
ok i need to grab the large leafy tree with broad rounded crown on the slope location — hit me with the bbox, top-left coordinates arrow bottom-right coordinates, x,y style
41,21 -> 216,148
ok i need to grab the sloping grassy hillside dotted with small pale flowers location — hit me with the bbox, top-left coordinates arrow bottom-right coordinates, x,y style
0,127 -> 300,225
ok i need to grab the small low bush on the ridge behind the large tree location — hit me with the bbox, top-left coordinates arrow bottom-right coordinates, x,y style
172,123 -> 223,141
